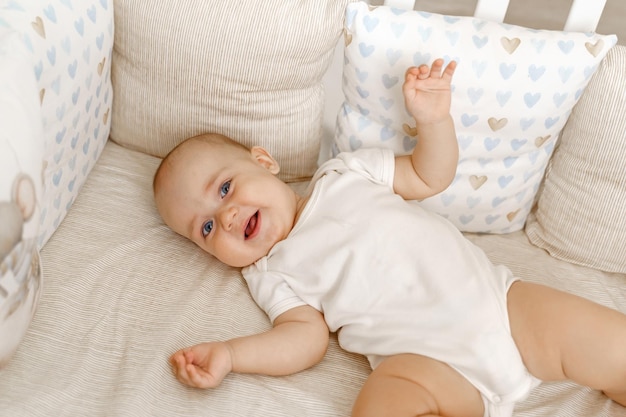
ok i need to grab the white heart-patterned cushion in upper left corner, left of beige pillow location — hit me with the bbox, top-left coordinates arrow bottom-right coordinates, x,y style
0,0 -> 113,248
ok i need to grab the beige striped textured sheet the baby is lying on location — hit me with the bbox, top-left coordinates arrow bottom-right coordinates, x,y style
0,142 -> 626,417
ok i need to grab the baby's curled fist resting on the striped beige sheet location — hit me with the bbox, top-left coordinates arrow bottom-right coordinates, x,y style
170,342 -> 232,388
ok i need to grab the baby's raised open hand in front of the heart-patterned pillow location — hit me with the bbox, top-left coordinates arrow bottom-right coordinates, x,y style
402,58 -> 456,124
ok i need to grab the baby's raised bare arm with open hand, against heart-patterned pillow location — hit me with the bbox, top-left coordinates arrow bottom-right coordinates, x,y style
393,59 -> 459,200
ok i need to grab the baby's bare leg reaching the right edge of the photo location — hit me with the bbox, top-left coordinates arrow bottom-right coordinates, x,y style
508,282 -> 626,406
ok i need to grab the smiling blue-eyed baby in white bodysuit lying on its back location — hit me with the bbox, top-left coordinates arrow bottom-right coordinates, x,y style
154,59 -> 626,417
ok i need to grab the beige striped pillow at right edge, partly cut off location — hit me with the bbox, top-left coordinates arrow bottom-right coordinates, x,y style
526,46 -> 626,273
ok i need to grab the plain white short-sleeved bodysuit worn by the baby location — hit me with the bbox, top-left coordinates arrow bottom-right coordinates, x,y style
242,149 -> 538,417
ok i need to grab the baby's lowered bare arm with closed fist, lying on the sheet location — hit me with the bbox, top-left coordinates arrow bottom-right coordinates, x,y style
170,306 -> 329,388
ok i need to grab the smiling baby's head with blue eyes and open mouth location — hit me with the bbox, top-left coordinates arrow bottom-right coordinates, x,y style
155,140 -> 299,267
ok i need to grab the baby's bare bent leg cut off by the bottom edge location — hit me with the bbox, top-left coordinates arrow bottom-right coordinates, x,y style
352,354 -> 484,417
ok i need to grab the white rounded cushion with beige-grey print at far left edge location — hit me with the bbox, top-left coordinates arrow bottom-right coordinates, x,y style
0,29 -> 44,368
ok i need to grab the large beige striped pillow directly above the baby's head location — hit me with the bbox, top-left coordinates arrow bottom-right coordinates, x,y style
111,0 -> 350,180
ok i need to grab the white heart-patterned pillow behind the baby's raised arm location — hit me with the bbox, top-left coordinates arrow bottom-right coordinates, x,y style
334,2 -> 617,233
